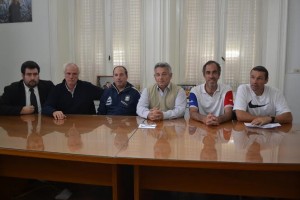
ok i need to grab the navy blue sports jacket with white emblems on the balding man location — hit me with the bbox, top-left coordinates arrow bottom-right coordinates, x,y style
97,82 -> 141,116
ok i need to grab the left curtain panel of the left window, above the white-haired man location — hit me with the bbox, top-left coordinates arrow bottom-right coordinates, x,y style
74,0 -> 106,83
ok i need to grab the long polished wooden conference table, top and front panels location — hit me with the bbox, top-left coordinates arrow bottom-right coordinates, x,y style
0,115 -> 300,199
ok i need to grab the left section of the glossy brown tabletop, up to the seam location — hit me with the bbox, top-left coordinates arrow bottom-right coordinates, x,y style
0,115 -> 137,157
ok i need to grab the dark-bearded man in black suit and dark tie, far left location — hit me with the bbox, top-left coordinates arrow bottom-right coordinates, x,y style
0,61 -> 54,115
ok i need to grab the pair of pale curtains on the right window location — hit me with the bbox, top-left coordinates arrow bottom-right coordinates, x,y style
181,0 -> 261,90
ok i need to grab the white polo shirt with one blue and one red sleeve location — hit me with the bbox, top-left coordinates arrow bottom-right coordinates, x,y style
189,84 -> 233,116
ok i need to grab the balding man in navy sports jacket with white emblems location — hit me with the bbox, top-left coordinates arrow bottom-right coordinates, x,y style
97,66 -> 140,115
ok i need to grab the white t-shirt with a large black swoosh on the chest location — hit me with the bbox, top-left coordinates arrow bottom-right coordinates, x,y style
233,84 -> 291,116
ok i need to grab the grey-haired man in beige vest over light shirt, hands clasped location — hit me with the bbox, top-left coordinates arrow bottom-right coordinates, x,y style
137,62 -> 186,121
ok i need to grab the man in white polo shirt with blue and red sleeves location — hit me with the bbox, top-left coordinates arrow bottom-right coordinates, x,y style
189,60 -> 233,125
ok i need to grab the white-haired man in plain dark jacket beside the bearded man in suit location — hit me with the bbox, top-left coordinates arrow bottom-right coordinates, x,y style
42,63 -> 103,119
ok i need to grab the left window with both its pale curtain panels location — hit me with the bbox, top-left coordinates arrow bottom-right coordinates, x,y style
75,0 -> 141,86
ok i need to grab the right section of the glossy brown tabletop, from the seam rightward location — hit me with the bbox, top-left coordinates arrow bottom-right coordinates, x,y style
118,118 -> 300,163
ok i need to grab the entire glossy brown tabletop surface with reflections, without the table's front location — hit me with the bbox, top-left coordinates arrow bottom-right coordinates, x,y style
0,115 -> 300,163
